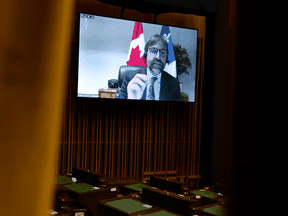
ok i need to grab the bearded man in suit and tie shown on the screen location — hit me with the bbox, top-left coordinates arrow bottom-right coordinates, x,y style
116,34 -> 181,101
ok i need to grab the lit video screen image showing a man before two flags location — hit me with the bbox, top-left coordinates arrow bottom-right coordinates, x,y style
77,13 -> 198,102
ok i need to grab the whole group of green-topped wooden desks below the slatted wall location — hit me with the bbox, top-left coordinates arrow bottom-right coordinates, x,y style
50,170 -> 227,216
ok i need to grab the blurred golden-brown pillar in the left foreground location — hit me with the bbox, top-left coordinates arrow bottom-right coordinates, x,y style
0,0 -> 74,216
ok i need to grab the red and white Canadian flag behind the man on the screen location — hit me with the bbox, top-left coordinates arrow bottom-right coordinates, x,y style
127,22 -> 147,66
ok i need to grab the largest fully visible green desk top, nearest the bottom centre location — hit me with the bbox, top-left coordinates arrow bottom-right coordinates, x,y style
105,198 -> 152,214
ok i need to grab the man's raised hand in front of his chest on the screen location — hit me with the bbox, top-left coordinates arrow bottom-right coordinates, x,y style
127,74 -> 147,99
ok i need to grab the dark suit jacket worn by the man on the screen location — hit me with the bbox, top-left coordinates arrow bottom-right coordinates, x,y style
115,68 -> 181,101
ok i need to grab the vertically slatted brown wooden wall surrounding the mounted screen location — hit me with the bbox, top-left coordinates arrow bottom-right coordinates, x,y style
58,0 -> 205,187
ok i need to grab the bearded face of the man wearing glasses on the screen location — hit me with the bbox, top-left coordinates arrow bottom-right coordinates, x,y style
147,40 -> 167,76
